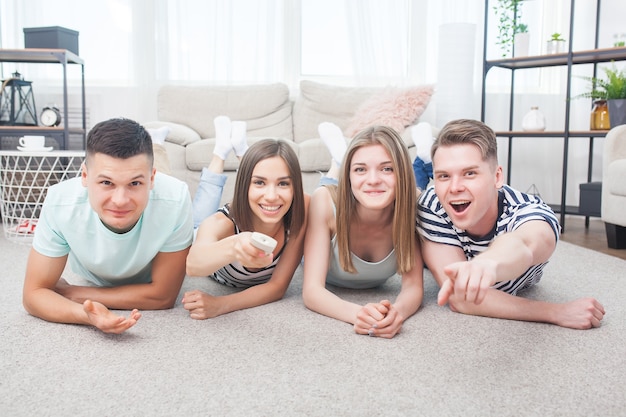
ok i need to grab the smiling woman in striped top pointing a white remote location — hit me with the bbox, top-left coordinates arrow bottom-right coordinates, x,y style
182,119 -> 309,319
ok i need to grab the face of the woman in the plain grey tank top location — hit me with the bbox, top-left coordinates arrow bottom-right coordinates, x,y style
350,145 -> 396,209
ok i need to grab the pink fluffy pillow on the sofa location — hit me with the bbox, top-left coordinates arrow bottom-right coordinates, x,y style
345,85 -> 435,138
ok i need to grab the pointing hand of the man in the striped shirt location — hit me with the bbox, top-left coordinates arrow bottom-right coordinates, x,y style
437,258 -> 497,306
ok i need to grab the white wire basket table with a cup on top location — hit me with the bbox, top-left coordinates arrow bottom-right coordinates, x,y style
0,151 -> 85,244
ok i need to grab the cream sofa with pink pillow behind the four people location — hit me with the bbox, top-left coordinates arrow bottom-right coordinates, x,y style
144,81 -> 434,202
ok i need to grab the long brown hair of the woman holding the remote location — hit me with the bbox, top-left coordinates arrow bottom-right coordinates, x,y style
230,139 -> 304,235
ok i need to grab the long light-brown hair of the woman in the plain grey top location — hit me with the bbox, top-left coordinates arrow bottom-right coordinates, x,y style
336,126 -> 417,274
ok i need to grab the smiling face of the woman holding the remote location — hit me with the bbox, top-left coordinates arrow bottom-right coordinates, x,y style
248,156 -> 294,229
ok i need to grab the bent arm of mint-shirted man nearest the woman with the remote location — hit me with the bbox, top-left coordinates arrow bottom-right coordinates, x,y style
55,248 -> 189,310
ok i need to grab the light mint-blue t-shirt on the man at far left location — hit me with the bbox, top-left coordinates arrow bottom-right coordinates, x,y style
33,172 -> 193,287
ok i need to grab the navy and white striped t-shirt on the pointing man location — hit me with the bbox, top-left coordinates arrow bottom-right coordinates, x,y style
418,185 -> 561,295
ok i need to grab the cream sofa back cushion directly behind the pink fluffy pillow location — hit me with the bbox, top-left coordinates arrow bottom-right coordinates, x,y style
293,80 -> 381,143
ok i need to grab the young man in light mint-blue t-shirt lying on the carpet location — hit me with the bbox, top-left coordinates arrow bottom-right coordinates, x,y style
23,119 -> 193,333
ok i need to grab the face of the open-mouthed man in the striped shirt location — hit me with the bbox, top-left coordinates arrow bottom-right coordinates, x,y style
433,144 -> 504,236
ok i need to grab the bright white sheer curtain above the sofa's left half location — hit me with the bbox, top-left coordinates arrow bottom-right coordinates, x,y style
155,0 -> 285,83
